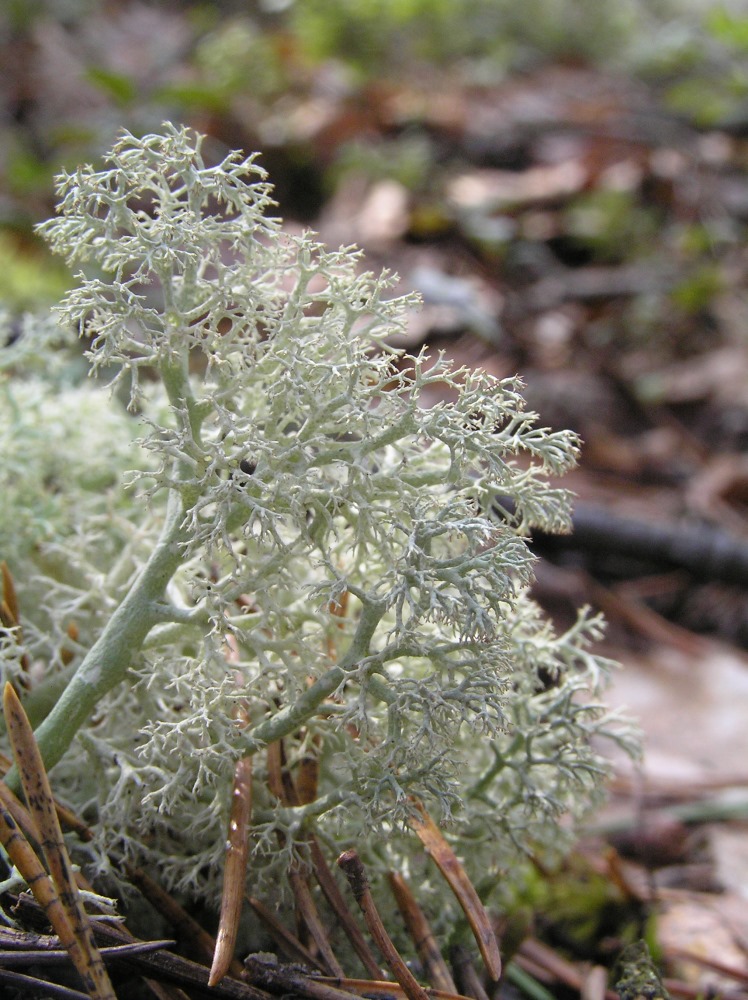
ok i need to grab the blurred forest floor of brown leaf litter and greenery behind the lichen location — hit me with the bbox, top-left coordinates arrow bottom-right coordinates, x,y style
0,0 -> 748,996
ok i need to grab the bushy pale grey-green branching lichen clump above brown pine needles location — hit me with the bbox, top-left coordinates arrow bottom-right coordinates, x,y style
0,126 -> 629,912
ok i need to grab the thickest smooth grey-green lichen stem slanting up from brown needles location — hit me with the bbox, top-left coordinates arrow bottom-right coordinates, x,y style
5,492 -> 188,791
